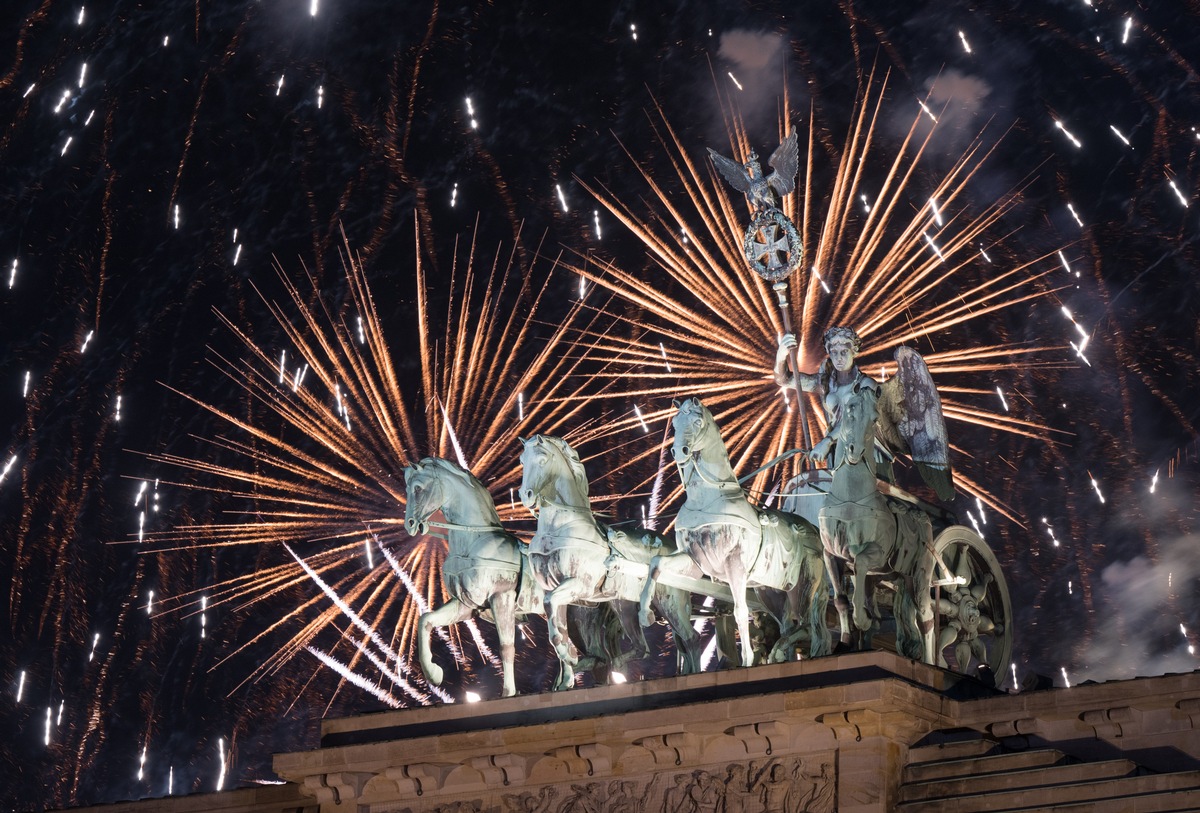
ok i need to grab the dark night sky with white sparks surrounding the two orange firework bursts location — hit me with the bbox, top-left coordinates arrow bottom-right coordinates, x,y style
0,0 -> 1200,809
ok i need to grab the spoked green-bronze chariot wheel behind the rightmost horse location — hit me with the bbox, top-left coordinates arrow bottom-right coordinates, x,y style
925,525 -> 1013,686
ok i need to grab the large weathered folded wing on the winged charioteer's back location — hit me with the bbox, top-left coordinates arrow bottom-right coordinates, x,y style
876,348 -> 954,501
